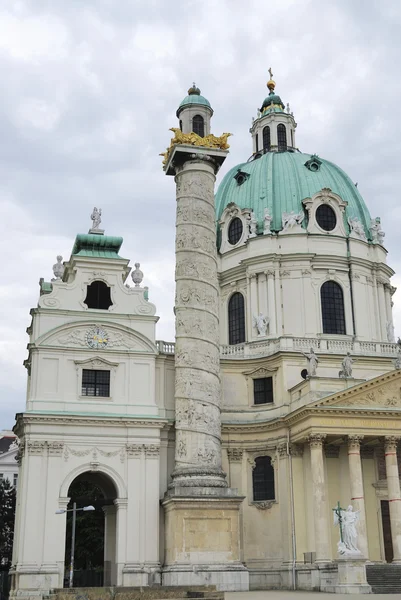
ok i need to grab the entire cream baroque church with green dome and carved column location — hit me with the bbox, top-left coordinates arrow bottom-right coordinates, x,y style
8,79 -> 401,597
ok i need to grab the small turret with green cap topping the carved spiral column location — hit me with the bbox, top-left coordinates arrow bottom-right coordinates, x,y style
177,82 -> 213,137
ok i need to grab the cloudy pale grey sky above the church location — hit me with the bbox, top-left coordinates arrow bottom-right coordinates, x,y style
0,0 -> 401,429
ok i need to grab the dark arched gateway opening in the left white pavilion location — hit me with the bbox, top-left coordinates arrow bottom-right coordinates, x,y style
64,472 -> 118,587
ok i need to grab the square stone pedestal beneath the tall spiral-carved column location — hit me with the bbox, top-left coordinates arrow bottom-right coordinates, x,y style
162,488 -> 249,591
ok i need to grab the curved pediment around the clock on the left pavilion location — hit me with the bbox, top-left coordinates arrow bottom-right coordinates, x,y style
36,321 -> 157,354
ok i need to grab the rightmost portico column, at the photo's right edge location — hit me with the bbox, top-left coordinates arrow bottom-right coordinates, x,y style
384,435 -> 401,563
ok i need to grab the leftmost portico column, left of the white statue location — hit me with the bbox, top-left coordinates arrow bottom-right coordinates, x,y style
308,433 -> 331,563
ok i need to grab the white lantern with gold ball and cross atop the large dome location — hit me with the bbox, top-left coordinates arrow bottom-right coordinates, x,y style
250,68 -> 297,155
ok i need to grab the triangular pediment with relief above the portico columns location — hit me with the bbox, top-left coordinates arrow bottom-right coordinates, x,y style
314,370 -> 401,410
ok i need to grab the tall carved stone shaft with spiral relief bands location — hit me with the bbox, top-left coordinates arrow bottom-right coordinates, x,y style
172,154 -> 227,487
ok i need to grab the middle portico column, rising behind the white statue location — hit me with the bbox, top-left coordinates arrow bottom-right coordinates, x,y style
348,435 -> 369,558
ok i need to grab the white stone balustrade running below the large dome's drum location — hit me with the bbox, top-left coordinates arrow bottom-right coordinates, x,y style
156,337 -> 399,359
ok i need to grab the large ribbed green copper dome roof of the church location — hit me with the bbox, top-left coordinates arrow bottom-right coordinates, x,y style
216,152 -> 371,239
